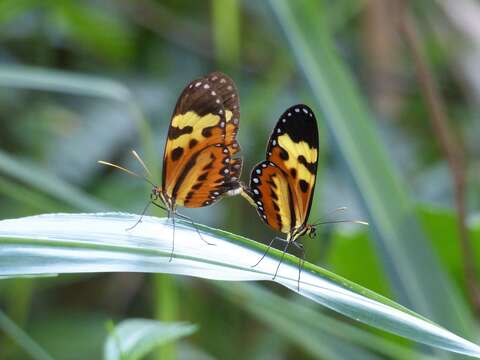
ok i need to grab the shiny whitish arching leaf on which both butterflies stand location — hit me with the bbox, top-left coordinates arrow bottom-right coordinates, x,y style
0,213 -> 480,358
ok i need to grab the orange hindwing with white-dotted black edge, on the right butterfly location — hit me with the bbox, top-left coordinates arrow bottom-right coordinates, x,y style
248,161 -> 296,233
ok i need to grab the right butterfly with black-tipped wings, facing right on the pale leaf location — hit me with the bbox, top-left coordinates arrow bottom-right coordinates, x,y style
241,104 -> 366,288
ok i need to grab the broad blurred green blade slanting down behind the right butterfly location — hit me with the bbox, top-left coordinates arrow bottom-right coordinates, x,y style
270,0 -> 474,336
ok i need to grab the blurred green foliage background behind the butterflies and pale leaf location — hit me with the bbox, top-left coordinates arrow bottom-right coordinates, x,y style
0,0 -> 480,359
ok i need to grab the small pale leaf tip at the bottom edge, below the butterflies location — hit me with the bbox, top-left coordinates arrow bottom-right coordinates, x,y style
104,319 -> 197,360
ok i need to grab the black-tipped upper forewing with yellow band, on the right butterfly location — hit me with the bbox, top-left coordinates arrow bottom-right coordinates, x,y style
267,104 -> 318,228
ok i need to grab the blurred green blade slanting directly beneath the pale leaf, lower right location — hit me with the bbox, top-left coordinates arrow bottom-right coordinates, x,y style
218,284 -> 433,360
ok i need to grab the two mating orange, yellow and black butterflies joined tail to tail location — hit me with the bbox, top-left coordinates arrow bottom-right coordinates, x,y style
102,72 -> 356,288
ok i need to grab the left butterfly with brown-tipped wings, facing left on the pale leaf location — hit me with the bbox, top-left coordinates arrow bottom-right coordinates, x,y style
100,72 -> 242,261
